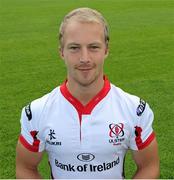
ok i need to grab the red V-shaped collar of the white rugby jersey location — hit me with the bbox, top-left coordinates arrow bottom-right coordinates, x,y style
60,76 -> 111,115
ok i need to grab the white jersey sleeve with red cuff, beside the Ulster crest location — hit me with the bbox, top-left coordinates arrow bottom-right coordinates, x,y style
129,99 -> 155,150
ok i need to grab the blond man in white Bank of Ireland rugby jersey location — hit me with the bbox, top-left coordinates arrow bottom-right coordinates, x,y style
16,8 -> 159,179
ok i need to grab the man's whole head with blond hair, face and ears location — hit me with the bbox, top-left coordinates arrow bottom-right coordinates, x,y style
59,8 -> 109,86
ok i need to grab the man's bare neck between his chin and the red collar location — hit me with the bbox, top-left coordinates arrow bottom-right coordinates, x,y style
67,76 -> 104,106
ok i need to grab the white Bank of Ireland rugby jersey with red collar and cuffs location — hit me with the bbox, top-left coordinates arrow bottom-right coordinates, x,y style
19,78 -> 155,179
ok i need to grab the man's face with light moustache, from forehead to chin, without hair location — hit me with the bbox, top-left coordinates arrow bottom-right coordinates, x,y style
61,21 -> 108,86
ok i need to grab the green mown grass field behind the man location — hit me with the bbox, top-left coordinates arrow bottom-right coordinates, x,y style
0,0 -> 174,179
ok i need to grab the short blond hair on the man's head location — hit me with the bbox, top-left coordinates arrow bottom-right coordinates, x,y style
59,7 -> 109,48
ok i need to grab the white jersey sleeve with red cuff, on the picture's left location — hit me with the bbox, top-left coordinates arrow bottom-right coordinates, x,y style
19,103 -> 45,152
